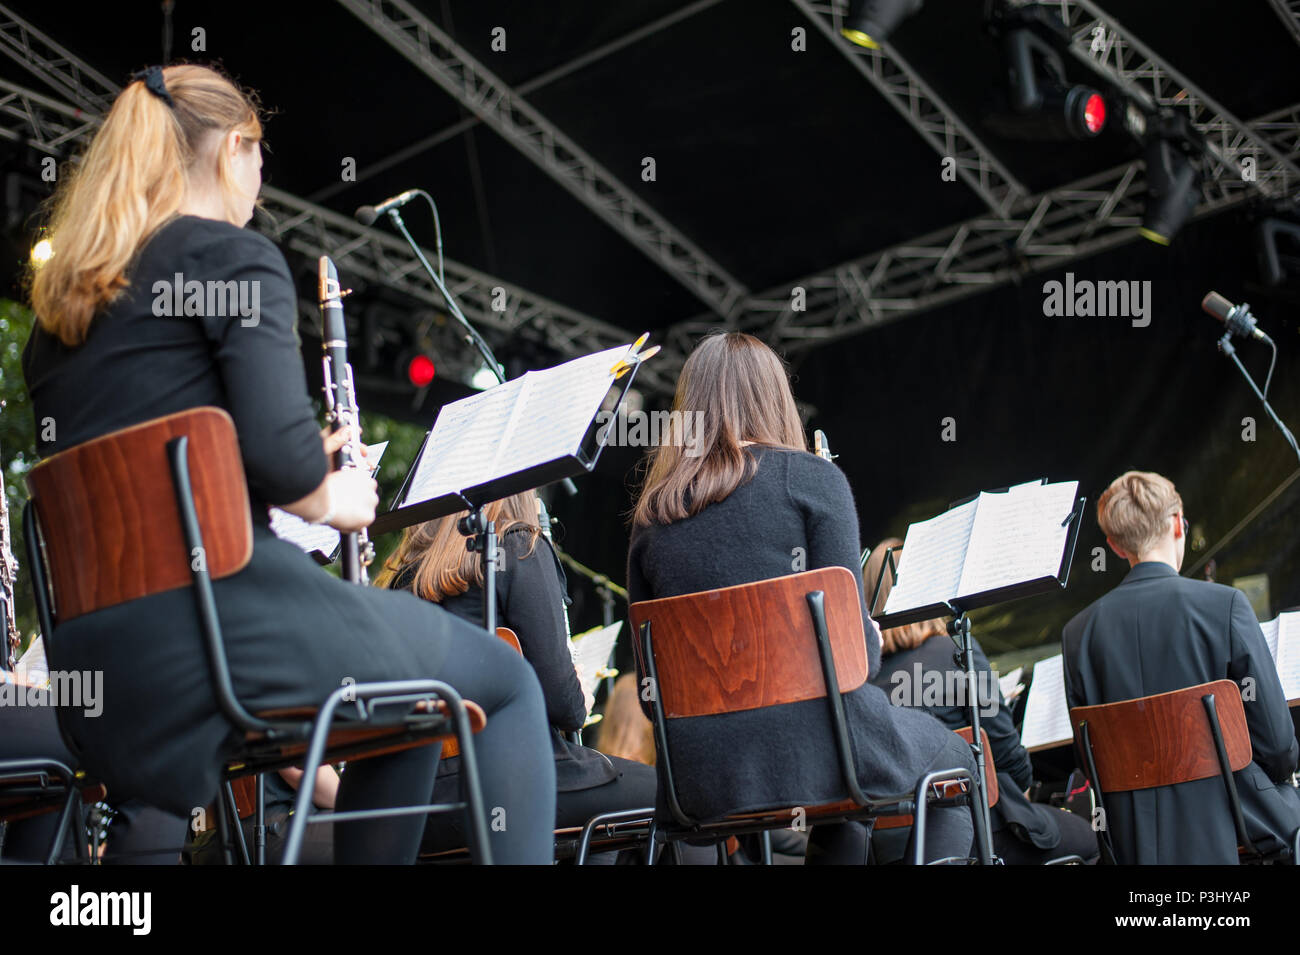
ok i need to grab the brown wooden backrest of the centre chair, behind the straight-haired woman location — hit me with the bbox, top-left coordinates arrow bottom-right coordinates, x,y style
632,567 -> 867,720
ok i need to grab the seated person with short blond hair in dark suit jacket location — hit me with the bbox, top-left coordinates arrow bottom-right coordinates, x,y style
1062,470 -> 1300,865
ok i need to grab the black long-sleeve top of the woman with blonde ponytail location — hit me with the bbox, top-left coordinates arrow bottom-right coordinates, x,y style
23,216 -> 329,524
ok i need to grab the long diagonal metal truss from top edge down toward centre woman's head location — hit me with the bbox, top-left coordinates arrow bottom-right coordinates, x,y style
338,0 -> 748,318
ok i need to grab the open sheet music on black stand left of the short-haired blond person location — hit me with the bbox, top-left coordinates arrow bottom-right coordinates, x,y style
865,481 -> 1082,628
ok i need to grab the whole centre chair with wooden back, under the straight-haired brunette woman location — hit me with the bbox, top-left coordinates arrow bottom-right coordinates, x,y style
632,567 -> 992,864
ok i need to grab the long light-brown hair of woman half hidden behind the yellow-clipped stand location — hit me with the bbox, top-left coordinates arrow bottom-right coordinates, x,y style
374,491 -> 542,603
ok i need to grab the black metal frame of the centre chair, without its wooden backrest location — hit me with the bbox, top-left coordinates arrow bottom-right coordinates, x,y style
641,590 -> 992,865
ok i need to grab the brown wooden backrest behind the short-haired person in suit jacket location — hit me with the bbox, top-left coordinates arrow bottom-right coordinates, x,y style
1070,680 -> 1252,793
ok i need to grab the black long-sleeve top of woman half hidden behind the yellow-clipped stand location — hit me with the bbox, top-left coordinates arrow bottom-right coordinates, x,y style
393,528 -> 618,793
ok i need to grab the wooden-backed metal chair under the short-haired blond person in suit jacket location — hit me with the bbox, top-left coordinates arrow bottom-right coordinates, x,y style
1070,680 -> 1300,864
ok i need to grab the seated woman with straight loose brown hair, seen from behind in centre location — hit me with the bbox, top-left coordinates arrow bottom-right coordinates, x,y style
628,333 -> 974,864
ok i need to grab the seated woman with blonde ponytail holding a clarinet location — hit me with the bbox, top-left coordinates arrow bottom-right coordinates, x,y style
23,65 -> 555,863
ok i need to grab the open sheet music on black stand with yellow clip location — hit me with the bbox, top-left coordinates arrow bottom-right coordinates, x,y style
372,346 -> 651,535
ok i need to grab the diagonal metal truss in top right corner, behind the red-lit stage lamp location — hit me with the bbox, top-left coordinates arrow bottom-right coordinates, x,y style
1015,0 -> 1300,197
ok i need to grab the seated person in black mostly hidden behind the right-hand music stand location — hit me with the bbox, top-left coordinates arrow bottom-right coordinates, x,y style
862,538 -> 1099,865
